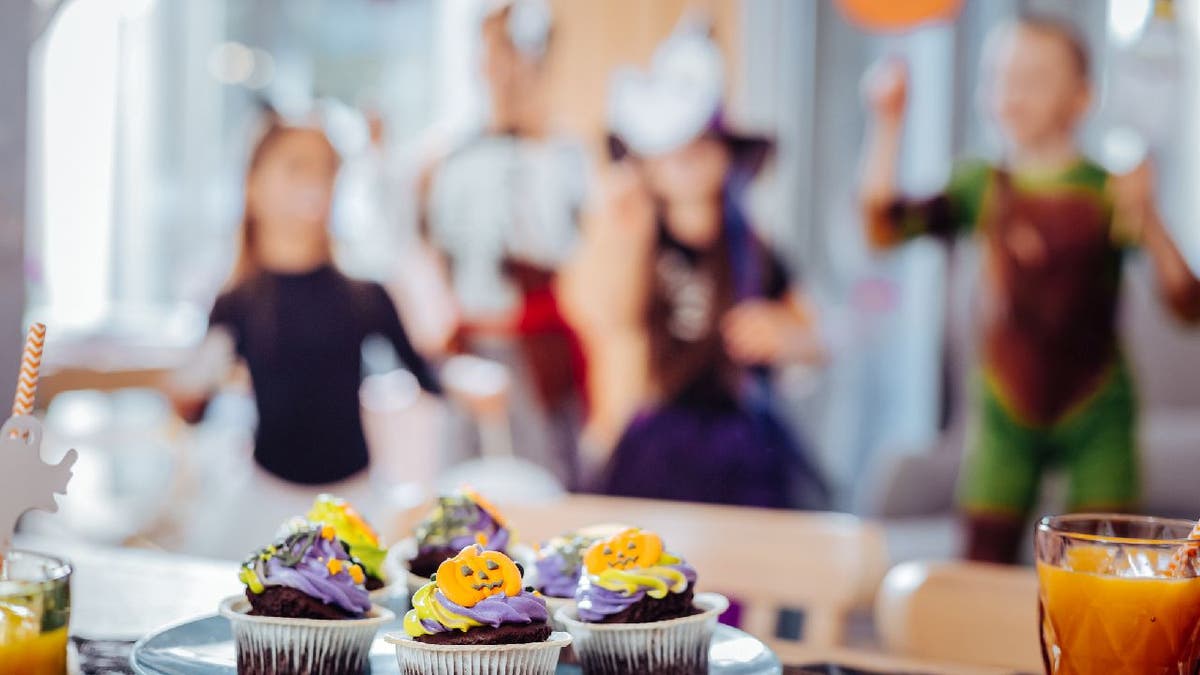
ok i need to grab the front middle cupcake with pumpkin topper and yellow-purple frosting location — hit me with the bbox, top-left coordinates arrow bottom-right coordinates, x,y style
386,544 -> 570,674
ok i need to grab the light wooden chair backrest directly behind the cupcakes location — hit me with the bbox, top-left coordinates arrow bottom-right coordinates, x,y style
492,495 -> 888,644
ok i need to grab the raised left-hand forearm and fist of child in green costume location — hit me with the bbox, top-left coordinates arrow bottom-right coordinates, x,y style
858,61 -> 908,249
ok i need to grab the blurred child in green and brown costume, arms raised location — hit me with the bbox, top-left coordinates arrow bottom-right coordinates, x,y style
860,18 -> 1200,562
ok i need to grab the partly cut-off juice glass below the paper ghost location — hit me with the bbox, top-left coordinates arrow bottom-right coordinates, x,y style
0,550 -> 71,675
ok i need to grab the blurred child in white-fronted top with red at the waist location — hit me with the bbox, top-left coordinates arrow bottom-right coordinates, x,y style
421,0 -> 587,486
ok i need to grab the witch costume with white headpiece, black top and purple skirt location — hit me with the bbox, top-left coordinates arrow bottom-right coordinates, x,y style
599,22 -> 827,508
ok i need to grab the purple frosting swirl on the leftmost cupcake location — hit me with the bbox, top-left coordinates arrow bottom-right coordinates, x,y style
262,526 -> 371,614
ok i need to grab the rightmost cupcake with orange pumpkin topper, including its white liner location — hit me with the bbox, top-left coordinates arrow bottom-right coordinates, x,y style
556,528 -> 728,675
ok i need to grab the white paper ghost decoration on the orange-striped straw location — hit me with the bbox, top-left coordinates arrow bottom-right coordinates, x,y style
0,414 -> 78,555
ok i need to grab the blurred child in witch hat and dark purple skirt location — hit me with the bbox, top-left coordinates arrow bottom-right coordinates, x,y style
562,19 -> 826,507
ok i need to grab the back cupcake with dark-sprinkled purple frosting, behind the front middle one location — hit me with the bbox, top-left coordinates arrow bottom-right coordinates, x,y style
408,488 -> 510,579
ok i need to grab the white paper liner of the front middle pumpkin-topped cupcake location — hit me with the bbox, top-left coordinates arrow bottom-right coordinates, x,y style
384,633 -> 571,675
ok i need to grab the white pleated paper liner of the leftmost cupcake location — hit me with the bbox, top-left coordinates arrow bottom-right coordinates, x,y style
221,596 -> 396,675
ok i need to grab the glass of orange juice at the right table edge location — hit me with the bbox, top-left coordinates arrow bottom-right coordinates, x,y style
1037,514 -> 1200,675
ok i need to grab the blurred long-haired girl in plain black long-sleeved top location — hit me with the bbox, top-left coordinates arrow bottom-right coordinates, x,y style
175,118 -> 439,484
